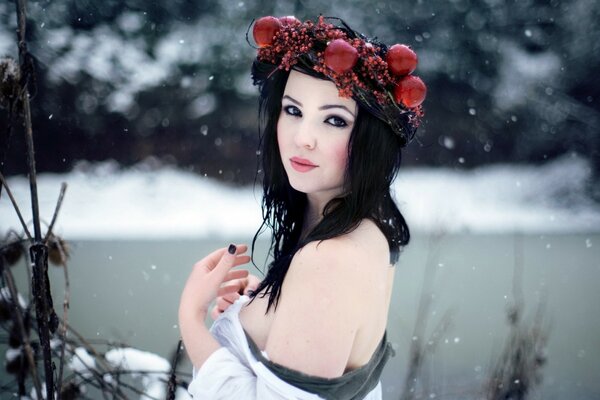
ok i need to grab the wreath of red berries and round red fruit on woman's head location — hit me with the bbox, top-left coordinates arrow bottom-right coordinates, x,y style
253,16 -> 427,133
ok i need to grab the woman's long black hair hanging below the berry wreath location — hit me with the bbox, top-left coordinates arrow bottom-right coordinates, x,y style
250,61 -> 410,312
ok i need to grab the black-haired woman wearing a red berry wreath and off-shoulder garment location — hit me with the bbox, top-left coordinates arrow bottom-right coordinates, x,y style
179,17 -> 425,399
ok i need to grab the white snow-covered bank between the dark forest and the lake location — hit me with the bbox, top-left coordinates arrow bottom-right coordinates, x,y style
0,156 -> 600,239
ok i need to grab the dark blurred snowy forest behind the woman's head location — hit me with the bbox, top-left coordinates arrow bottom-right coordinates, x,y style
0,0 -> 600,192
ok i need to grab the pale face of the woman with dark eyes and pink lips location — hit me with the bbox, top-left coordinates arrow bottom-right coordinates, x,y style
277,70 -> 358,201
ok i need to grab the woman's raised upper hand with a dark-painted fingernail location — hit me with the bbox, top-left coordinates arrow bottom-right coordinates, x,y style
179,245 -> 250,316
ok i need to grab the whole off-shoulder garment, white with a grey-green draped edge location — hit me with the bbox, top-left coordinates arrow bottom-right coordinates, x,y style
188,296 -> 393,400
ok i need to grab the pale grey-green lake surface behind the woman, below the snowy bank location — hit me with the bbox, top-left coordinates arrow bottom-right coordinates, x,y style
3,234 -> 600,400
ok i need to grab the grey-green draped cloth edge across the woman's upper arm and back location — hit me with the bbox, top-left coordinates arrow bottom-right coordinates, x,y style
244,331 -> 395,400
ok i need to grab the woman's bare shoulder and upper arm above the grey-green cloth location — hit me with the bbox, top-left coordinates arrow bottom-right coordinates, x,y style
265,221 -> 389,378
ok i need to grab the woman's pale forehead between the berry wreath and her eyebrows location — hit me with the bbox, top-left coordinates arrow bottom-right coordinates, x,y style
284,70 -> 356,110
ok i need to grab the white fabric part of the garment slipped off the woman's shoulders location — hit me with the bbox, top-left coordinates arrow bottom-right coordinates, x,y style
188,295 -> 382,400
